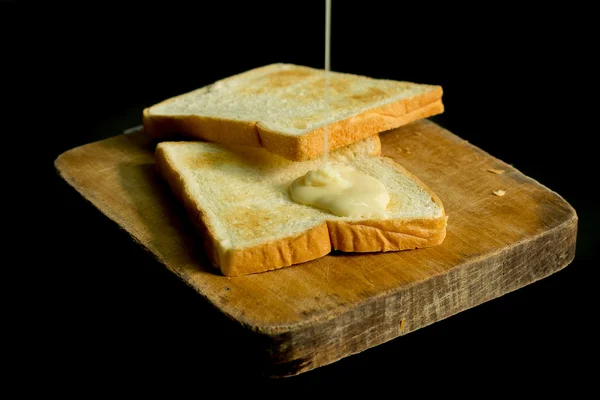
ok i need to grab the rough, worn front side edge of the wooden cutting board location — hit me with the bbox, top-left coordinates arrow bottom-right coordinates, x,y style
264,213 -> 578,377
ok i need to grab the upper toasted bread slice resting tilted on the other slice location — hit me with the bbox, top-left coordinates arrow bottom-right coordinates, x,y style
144,64 -> 444,161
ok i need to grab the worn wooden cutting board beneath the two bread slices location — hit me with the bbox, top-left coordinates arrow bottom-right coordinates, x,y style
55,120 -> 577,376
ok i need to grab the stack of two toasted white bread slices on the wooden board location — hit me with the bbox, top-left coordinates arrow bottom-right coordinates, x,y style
144,64 -> 447,276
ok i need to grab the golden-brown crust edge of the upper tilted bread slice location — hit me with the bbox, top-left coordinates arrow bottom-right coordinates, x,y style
143,78 -> 444,161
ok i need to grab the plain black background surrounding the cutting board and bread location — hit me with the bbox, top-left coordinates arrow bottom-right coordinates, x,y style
11,0 -> 599,395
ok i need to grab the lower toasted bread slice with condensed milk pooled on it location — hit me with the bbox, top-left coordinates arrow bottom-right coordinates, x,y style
156,135 -> 446,276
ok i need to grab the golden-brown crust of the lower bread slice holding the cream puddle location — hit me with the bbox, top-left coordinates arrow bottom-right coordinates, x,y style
156,136 -> 447,276
